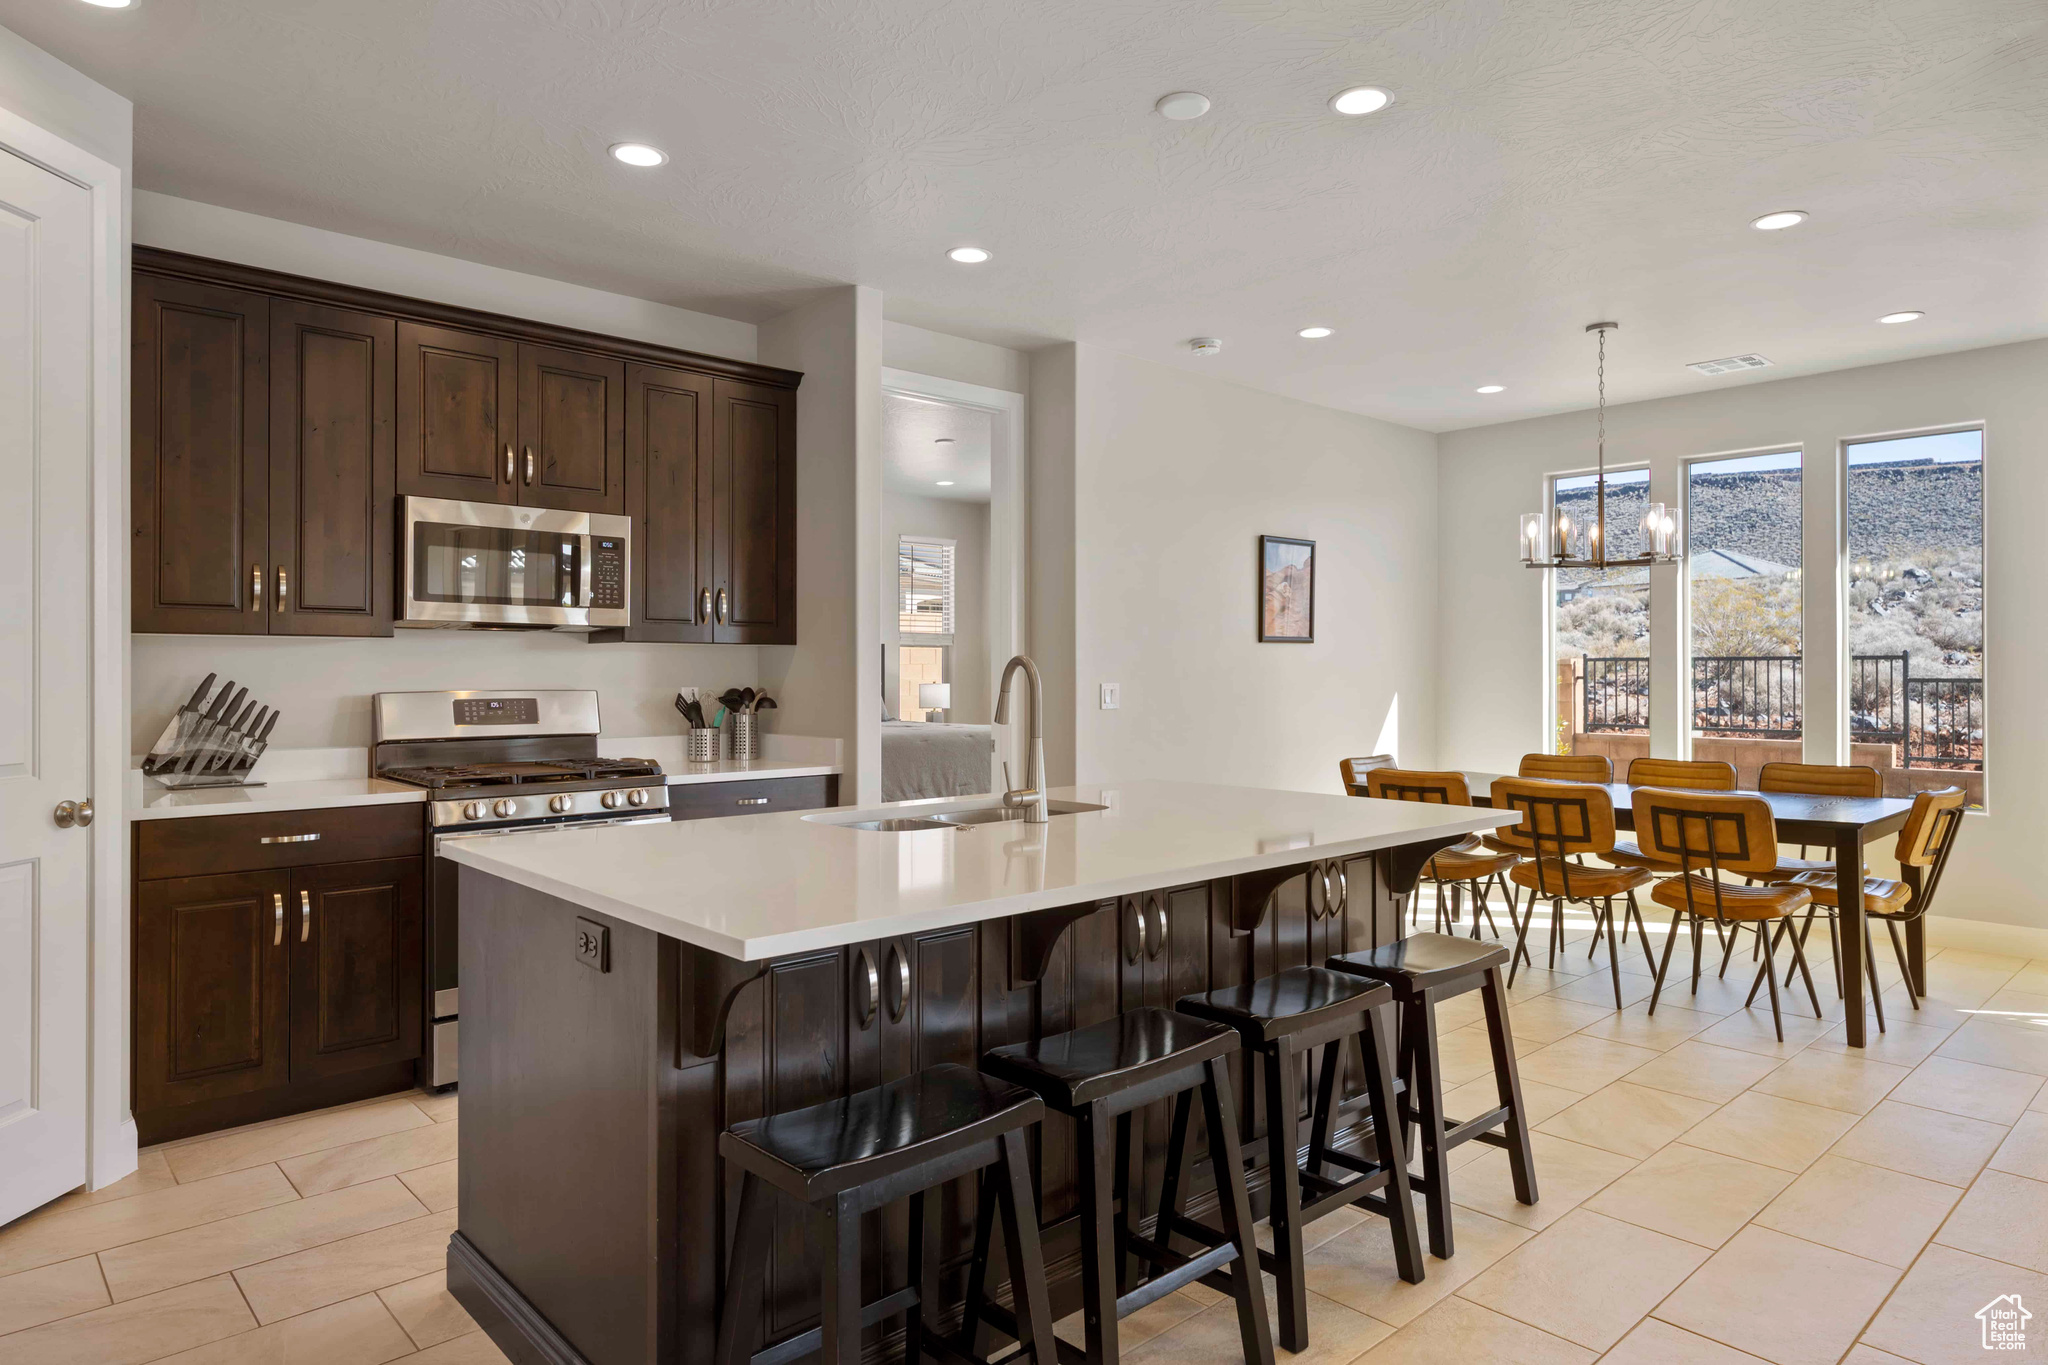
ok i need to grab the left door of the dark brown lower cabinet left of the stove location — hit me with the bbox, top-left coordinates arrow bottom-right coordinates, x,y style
135,872 -> 291,1109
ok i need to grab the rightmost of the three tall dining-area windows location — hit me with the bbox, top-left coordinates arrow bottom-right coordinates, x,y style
1845,430 -> 1985,806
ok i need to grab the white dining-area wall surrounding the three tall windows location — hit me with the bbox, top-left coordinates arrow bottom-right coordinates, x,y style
1438,342 -> 2048,925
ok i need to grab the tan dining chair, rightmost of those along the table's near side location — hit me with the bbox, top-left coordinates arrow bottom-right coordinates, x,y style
1632,788 -> 1821,1042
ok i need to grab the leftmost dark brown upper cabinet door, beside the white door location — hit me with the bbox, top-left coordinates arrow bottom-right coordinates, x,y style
129,274 -> 270,634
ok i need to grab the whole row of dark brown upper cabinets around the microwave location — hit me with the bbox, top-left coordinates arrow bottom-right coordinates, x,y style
133,248 -> 803,645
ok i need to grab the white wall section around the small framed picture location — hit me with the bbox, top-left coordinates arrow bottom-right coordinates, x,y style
1034,346 -> 1436,792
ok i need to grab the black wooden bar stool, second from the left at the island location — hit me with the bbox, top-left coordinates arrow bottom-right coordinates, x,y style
963,1007 -> 1274,1365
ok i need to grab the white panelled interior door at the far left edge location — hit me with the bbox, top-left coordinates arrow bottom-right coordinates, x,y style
0,151 -> 96,1222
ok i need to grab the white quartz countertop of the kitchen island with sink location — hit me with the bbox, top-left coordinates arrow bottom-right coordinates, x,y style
442,782 -> 1516,962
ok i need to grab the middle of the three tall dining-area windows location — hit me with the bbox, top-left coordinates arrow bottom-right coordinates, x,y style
1686,450 -> 1804,749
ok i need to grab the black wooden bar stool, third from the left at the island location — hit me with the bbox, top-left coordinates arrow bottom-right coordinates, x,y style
1159,966 -> 1423,1351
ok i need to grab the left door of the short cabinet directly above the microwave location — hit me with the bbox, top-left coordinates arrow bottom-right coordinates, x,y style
397,321 -> 518,503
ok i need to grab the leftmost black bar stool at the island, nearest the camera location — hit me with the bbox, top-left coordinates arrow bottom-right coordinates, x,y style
717,1064 -> 1057,1365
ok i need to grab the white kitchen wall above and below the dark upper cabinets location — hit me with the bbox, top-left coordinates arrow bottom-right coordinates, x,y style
129,192 -> 770,753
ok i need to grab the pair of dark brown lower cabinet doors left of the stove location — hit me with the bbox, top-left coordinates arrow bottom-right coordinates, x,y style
133,857 -> 424,1144
